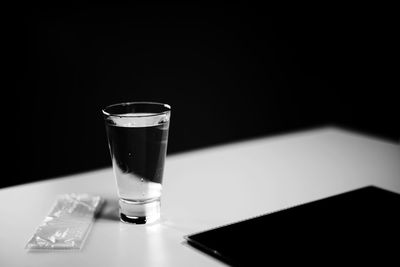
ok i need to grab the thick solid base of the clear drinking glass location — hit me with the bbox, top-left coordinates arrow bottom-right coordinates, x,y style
119,198 -> 160,224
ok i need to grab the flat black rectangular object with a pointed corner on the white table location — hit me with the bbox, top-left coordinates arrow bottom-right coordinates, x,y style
185,186 -> 400,266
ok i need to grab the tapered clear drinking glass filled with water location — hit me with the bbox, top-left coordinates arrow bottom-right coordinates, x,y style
102,102 -> 171,224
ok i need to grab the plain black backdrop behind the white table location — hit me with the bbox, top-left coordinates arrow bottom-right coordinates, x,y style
4,4 -> 399,186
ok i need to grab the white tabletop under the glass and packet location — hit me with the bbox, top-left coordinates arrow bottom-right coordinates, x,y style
0,127 -> 400,267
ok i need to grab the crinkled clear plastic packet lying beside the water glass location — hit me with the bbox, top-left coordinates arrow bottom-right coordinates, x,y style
25,194 -> 102,250
